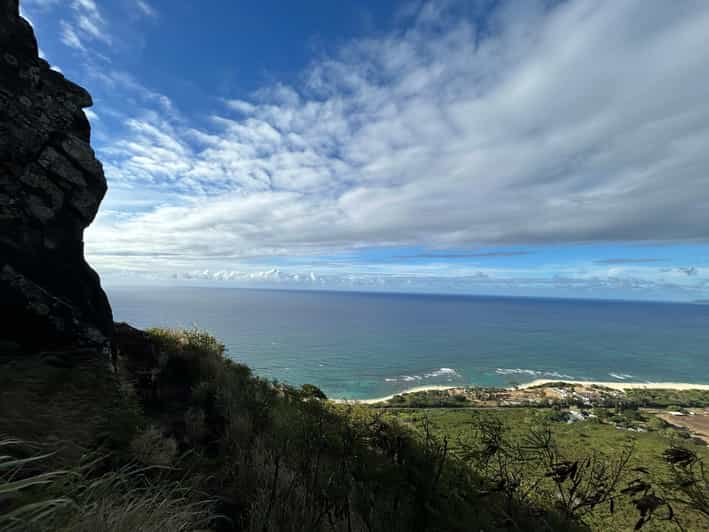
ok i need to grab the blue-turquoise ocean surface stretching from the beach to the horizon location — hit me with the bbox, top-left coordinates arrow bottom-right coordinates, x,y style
107,287 -> 709,399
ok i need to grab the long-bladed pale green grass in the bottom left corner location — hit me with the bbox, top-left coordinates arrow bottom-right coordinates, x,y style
0,439 -> 213,532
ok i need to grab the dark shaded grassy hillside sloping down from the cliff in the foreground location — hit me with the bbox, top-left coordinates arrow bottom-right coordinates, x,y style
0,329 -> 576,532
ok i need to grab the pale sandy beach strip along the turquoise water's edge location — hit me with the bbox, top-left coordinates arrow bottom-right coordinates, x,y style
331,379 -> 709,405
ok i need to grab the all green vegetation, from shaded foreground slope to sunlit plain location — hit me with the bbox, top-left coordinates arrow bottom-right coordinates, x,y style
5,329 -> 709,532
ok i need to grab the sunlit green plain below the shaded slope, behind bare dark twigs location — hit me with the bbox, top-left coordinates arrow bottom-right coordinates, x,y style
388,408 -> 709,531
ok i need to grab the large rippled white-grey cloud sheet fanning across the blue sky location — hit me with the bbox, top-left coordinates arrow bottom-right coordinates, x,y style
87,0 -> 709,290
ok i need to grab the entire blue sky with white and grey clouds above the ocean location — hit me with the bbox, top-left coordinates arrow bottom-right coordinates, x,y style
21,0 -> 709,301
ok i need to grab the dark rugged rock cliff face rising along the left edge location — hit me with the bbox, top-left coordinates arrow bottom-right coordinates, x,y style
0,0 -> 113,351
